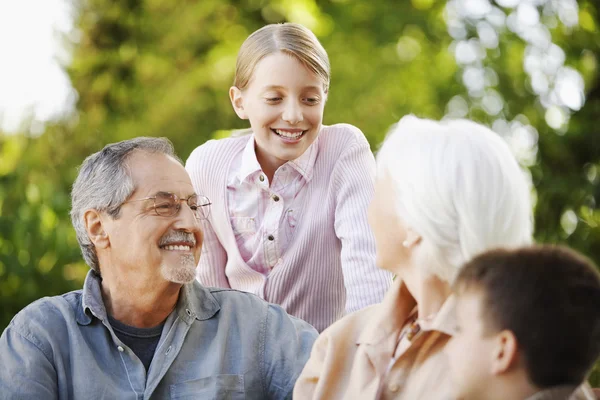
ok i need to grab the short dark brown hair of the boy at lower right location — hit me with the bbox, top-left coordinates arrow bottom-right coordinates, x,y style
454,246 -> 600,388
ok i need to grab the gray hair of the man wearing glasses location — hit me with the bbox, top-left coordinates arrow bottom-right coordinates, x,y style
71,137 -> 183,273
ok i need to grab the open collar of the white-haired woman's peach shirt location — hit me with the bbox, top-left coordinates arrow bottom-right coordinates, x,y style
357,278 -> 456,345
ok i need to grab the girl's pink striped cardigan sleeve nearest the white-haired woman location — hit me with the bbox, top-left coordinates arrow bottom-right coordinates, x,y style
333,139 -> 392,313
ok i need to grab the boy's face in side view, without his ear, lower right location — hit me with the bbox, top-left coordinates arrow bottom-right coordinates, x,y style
445,289 -> 494,400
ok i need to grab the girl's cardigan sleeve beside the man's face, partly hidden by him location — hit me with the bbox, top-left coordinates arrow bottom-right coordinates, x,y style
185,142 -> 230,288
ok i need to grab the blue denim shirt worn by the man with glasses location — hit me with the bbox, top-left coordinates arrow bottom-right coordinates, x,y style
0,271 -> 317,399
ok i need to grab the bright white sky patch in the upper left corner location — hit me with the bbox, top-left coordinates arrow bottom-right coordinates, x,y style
0,0 -> 76,134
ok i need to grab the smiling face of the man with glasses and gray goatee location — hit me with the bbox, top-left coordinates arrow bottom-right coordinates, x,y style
105,151 -> 202,283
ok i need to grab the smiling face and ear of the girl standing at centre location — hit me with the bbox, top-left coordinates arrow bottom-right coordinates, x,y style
230,52 -> 327,180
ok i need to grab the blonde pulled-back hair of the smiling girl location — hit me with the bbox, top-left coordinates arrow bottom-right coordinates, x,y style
233,23 -> 331,93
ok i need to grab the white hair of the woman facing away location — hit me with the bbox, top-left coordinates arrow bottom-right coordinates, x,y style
377,115 -> 533,282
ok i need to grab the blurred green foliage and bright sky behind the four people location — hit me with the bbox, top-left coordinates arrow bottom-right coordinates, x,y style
0,0 -> 600,386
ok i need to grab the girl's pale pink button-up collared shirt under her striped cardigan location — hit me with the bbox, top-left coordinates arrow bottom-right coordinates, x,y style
227,137 -> 319,274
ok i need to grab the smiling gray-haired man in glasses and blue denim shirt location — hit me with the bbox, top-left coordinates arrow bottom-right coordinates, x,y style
0,138 -> 317,399
